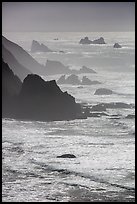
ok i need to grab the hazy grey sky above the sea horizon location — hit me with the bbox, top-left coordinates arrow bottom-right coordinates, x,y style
2,2 -> 135,32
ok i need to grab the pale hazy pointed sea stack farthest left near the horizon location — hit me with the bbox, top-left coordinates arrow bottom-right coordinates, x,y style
31,40 -> 52,53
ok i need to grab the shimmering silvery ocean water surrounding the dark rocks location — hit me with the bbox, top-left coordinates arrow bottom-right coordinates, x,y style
2,32 -> 135,202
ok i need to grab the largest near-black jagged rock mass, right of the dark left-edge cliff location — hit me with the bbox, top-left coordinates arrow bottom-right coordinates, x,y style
12,75 -> 81,121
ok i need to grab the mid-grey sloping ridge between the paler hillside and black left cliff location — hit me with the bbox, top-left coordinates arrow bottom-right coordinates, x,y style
2,45 -> 31,81
